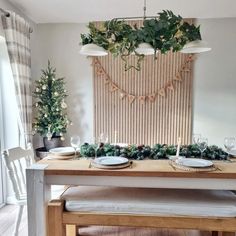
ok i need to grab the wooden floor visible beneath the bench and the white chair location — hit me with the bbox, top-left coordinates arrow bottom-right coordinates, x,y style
0,205 -> 214,236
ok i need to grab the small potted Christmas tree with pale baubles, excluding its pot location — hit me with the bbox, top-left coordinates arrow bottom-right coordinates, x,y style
33,61 -> 71,140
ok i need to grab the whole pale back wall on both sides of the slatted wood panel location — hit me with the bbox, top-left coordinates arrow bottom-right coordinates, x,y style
33,18 -> 236,146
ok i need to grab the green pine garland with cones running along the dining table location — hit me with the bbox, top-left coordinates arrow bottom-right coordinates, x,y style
80,143 -> 228,160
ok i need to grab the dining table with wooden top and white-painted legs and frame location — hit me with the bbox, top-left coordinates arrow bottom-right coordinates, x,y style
26,159 -> 236,236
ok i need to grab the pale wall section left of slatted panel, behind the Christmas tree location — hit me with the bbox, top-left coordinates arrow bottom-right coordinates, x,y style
33,24 -> 93,146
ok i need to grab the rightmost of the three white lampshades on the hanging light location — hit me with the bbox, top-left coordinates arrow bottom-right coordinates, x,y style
180,40 -> 211,53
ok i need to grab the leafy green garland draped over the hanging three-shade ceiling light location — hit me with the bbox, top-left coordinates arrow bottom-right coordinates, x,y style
81,10 -> 201,70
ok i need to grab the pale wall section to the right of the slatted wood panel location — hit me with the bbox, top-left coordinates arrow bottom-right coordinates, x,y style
193,18 -> 236,146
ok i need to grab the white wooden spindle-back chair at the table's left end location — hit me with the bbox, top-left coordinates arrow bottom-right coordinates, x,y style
2,147 -> 35,236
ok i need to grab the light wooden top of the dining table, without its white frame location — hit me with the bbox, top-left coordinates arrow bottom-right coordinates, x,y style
38,159 -> 236,179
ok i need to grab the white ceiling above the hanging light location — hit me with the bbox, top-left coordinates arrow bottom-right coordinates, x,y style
6,0 -> 236,23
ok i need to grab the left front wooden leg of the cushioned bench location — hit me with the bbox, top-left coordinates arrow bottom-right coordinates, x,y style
47,200 -> 66,236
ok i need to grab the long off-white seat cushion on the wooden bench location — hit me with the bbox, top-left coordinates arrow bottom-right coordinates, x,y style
61,186 -> 236,217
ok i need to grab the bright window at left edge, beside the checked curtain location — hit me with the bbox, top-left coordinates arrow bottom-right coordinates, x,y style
0,36 -> 19,206
